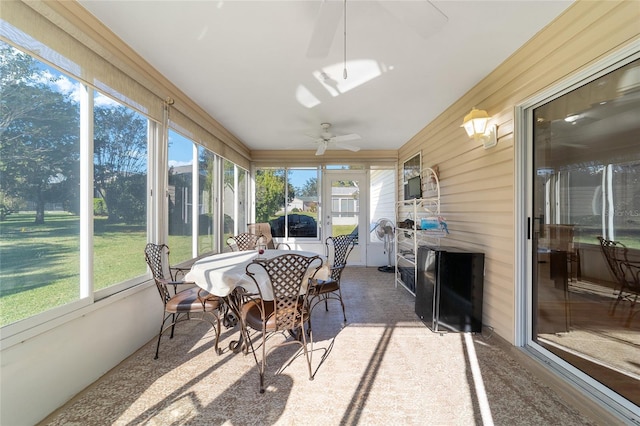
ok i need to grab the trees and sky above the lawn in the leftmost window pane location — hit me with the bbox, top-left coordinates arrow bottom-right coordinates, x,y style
0,43 -> 79,224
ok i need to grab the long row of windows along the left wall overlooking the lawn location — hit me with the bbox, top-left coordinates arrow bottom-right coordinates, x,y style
0,14 -> 248,339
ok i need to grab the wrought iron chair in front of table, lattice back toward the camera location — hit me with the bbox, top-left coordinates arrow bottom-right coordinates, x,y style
238,253 -> 322,393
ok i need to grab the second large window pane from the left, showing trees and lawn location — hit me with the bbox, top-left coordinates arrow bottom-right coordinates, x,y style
93,92 -> 148,290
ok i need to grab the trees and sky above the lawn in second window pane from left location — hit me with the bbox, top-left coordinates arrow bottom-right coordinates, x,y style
93,105 -> 147,223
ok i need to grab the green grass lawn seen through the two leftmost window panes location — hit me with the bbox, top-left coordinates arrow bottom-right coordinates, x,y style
0,213 -> 153,325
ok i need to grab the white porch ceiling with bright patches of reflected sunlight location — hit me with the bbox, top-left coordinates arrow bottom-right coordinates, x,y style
80,0 -> 571,154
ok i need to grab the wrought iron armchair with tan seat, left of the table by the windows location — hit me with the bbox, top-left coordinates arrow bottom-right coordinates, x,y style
144,243 -> 222,359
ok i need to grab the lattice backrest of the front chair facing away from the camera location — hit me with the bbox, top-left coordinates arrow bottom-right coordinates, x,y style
246,253 -> 322,330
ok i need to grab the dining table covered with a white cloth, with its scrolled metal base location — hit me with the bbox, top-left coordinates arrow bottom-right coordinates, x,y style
184,249 -> 330,352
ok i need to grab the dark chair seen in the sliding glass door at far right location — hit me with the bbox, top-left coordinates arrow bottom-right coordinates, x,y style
598,237 -> 640,327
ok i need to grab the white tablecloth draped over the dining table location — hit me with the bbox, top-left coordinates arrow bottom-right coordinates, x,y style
185,250 -> 329,300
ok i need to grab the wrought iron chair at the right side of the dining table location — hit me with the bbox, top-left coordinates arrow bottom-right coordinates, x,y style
309,234 -> 355,322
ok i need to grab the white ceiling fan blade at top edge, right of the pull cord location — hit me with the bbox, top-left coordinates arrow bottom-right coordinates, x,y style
379,1 -> 449,39
